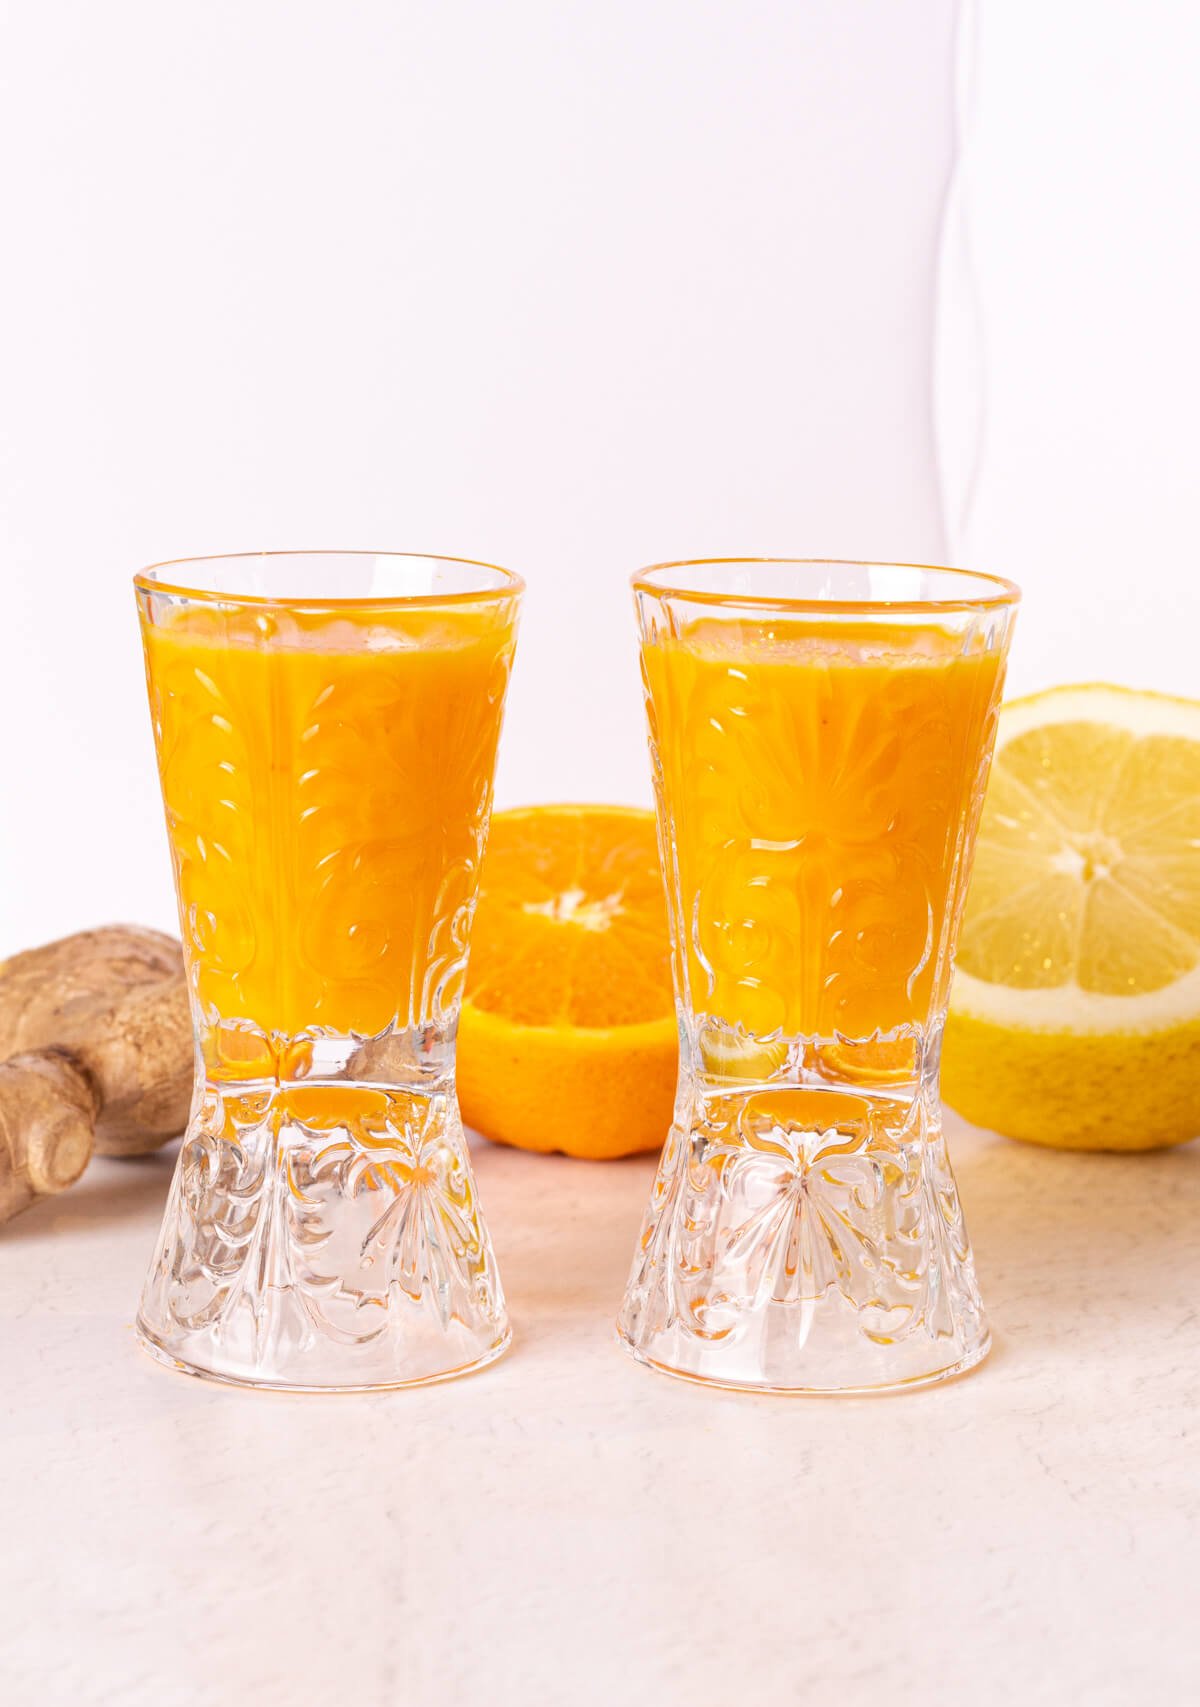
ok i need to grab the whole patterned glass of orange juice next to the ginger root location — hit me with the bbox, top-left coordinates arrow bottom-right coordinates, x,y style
135,551 -> 522,1389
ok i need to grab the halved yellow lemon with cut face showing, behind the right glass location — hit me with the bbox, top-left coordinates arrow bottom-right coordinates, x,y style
942,685 -> 1200,1149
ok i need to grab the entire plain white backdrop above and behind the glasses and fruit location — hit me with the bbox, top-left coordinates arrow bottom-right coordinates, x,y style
0,0 -> 1200,953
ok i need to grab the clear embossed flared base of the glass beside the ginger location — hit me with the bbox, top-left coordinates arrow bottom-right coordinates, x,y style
137,1079 -> 510,1391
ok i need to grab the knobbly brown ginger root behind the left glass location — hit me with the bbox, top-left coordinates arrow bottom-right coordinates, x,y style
0,925 -> 193,1222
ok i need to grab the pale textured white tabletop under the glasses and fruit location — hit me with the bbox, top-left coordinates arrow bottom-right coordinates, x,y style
0,1127 -> 1200,1707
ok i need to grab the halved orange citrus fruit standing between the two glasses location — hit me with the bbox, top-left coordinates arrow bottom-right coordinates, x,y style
457,806 -> 678,1157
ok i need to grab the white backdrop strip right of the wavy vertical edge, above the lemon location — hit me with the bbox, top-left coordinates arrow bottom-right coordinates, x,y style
949,0 -> 1200,696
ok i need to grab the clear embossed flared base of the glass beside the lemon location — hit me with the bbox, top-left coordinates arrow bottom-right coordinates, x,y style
618,1086 -> 990,1393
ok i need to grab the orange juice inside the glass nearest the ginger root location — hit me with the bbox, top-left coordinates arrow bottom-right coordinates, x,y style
143,601 -> 516,1038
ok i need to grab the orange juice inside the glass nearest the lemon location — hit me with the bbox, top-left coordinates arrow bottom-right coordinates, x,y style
644,620 -> 1000,1040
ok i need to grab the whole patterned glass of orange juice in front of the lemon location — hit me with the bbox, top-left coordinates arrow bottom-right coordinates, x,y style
618,560 -> 1017,1393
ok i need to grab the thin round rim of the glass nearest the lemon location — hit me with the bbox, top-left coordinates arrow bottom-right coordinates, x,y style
630,556 -> 1021,616
